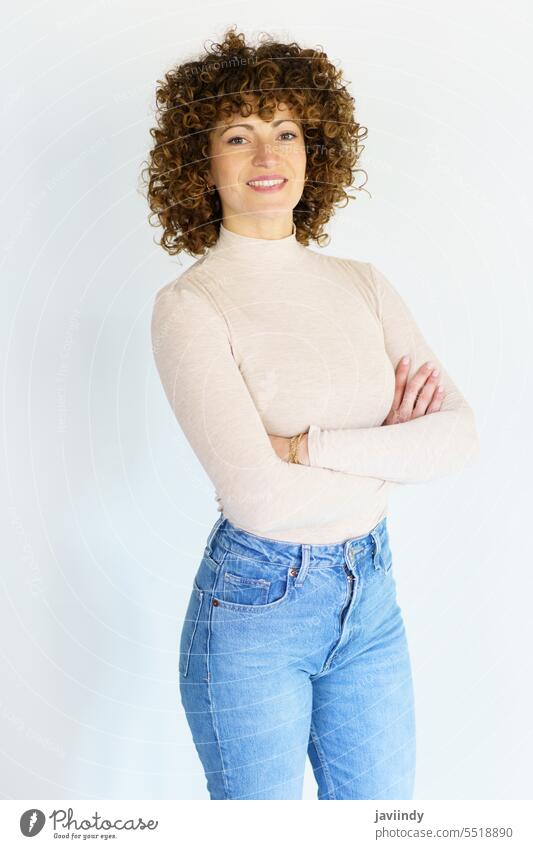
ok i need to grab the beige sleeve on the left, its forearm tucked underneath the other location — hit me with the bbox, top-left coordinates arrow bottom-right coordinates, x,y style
151,271 -> 383,539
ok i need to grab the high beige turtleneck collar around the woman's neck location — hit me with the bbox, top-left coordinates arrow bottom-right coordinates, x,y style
209,222 -> 305,268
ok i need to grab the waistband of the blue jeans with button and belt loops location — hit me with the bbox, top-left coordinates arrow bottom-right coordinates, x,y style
206,514 -> 387,568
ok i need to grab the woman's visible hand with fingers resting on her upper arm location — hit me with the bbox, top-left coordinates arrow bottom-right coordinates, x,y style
383,357 -> 444,425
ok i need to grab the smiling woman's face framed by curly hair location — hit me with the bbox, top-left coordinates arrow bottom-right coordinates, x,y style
209,103 -> 306,229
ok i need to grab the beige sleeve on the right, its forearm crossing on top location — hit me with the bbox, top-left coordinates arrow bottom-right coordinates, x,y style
308,263 -> 479,483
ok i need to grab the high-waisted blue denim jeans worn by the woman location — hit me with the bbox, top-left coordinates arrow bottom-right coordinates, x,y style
179,514 -> 415,799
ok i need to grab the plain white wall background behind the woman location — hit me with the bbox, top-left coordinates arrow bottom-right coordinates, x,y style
0,0 -> 533,799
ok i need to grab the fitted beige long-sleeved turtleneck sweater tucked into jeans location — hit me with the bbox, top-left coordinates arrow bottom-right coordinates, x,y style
152,225 -> 479,543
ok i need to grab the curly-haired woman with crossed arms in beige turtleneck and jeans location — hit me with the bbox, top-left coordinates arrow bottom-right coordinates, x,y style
144,24 -> 478,799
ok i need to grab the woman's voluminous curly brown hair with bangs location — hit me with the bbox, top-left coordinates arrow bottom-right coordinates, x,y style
141,27 -> 368,257
